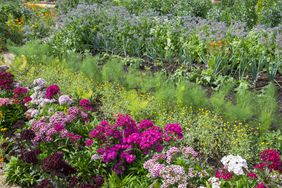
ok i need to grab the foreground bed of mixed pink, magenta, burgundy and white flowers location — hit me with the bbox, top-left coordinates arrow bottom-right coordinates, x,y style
0,68 -> 282,187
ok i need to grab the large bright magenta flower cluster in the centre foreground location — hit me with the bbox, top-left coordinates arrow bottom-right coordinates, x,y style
89,115 -> 182,174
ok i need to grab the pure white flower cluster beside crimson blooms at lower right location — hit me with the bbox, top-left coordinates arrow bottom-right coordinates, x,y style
221,155 -> 248,175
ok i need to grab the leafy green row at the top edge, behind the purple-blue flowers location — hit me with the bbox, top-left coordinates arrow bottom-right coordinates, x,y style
56,0 -> 282,28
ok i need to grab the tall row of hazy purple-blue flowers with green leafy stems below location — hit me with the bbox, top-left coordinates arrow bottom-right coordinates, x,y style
50,4 -> 282,84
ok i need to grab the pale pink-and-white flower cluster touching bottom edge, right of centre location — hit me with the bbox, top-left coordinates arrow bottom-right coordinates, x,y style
160,165 -> 188,188
